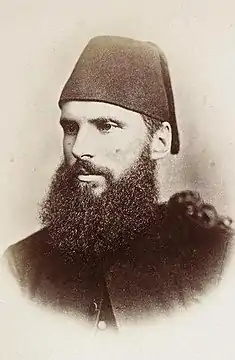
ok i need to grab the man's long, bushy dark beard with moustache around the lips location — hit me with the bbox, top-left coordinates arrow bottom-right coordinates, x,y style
39,149 -> 159,262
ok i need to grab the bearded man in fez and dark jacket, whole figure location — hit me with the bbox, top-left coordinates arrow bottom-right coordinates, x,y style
1,36 -> 233,329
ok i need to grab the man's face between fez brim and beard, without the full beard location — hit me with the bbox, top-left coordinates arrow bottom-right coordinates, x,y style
60,101 -> 149,195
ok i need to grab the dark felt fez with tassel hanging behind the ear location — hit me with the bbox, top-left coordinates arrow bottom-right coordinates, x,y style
59,36 -> 179,154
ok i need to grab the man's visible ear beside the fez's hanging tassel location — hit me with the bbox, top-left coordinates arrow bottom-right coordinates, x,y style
151,121 -> 172,160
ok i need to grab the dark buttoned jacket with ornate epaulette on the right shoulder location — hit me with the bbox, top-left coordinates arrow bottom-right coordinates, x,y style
1,192 -> 233,332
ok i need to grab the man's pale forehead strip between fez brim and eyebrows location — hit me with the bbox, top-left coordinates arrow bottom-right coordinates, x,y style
61,101 -> 144,125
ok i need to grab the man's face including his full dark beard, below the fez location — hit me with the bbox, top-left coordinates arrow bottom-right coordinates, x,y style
40,102 -> 158,261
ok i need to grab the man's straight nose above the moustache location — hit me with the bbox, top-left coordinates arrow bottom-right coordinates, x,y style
72,128 -> 95,159
